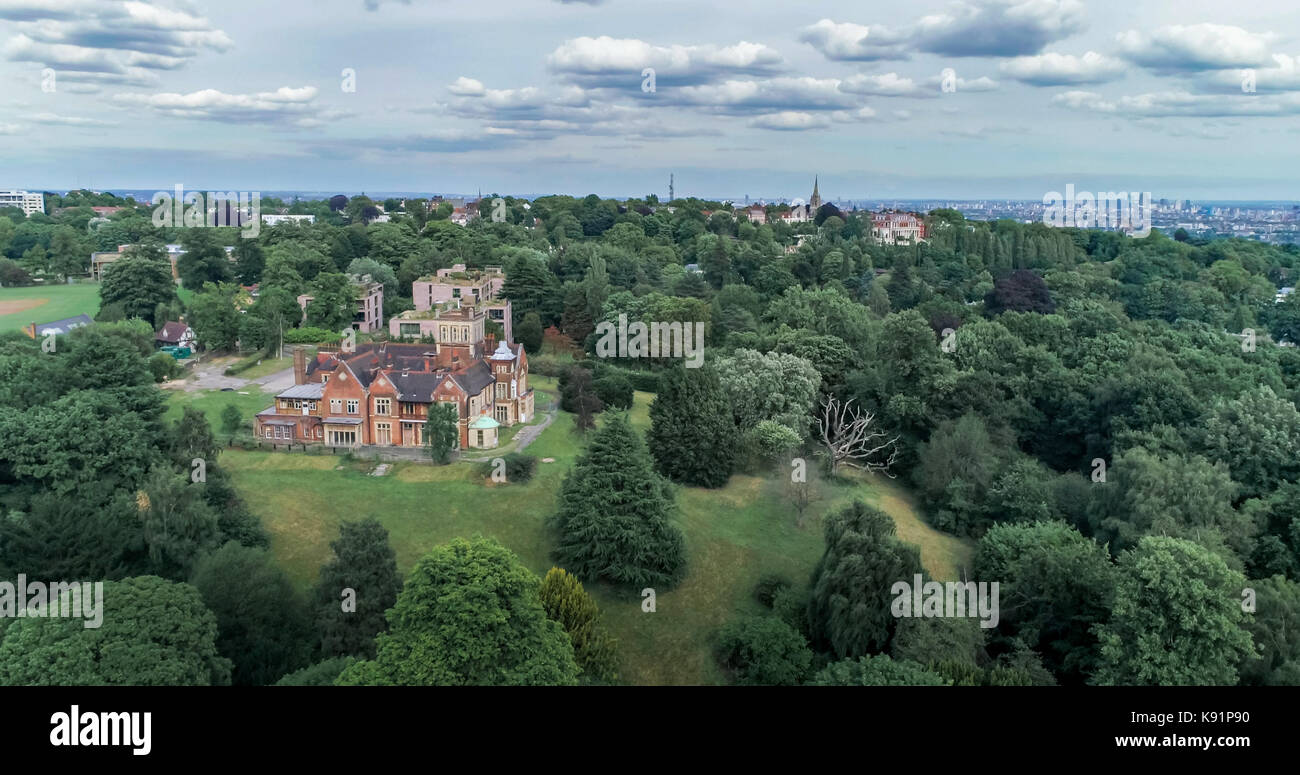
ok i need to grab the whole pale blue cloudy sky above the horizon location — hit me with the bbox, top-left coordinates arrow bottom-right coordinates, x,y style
0,0 -> 1300,200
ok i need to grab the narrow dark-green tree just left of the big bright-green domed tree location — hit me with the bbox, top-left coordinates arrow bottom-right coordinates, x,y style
312,516 -> 402,659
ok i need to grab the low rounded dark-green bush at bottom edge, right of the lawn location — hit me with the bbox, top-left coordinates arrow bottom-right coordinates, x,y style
718,616 -> 813,687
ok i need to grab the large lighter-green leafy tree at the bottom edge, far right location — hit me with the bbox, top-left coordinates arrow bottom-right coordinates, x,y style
1092,536 -> 1255,687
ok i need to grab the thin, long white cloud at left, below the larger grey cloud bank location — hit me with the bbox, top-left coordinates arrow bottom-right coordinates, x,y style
113,86 -> 341,126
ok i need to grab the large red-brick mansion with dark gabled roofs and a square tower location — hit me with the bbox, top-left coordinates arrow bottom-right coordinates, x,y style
255,306 -> 534,449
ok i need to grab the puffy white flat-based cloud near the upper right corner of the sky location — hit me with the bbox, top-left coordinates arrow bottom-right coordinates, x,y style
1115,23 -> 1271,72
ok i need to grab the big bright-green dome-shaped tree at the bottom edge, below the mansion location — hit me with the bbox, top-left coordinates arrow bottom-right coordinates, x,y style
338,538 -> 579,687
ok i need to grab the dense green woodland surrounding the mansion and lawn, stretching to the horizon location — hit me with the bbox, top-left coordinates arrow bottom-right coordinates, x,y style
0,192 -> 1300,685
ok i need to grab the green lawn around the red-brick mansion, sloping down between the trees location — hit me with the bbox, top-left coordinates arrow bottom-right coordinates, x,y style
213,387 -> 971,684
